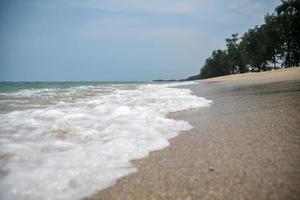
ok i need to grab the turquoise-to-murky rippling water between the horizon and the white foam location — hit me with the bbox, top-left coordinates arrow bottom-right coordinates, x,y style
0,82 -> 145,113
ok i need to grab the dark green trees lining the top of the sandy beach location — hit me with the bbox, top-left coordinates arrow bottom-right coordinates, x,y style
190,0 -> 300,79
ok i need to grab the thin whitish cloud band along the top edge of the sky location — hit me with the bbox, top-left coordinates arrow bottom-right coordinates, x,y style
65,0 -> 280,20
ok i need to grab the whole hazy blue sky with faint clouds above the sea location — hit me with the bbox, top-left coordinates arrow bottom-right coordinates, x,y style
0,0 -> 280,81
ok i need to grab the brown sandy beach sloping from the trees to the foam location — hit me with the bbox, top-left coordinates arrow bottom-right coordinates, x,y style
89,68 -> 300,200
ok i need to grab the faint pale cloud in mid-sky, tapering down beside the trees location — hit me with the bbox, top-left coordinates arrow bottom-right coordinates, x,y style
77,17 -> 220,78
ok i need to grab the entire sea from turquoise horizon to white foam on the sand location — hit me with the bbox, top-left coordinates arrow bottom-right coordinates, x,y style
0,82 -> 211,200
